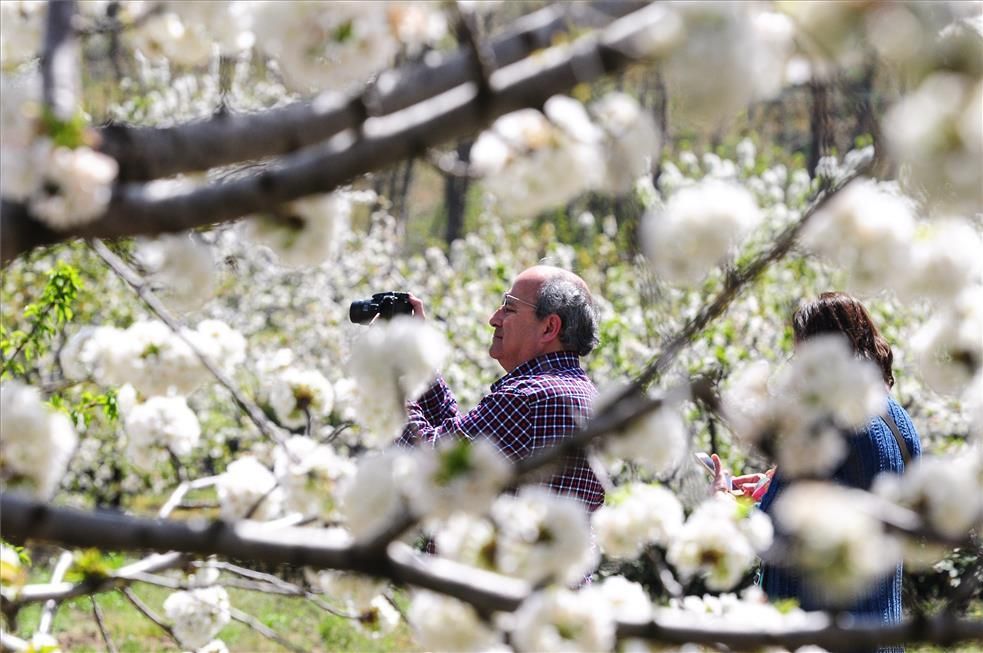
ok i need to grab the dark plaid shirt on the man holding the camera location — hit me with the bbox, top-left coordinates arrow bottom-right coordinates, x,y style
397,352 -> 604,511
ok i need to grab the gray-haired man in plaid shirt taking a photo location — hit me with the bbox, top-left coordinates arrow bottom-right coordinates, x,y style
399,265 -> 604,510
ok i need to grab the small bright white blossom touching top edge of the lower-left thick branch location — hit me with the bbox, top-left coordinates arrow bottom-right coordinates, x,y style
215,455 -> 283,521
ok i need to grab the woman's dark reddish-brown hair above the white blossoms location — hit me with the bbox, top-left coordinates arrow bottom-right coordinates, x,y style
792,292 -> 894,388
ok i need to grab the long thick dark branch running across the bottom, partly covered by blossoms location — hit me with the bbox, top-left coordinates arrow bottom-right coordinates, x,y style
0,494 -> 983,650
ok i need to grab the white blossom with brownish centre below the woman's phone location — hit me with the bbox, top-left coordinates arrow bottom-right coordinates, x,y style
666,493 -> 771,590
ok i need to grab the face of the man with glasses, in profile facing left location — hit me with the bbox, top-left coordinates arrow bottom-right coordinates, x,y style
488,275 -> 544,372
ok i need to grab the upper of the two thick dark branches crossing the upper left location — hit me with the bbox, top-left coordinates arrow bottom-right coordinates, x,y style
94,2 -> 642,181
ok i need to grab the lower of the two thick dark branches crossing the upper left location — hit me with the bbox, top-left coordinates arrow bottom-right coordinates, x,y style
0,5 -> 668,263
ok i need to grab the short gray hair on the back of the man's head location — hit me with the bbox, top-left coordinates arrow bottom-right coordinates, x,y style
536,274 -> 598,356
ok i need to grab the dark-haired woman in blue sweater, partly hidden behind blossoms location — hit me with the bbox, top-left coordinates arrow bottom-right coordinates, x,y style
715,292 -> 921,651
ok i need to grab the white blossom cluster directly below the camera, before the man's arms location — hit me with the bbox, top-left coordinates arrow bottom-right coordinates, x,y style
348,315 -> 447,446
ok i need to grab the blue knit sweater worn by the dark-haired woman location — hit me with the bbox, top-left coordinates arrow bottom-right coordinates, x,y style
761,397 -> 922,653
